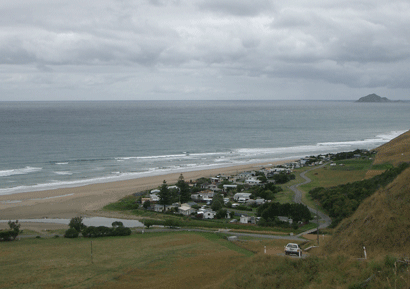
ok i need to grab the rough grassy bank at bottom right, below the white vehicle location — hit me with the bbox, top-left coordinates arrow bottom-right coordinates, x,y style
222,254 -> 410,289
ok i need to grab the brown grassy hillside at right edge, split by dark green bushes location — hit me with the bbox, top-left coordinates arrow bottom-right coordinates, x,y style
325,132 -> 410,257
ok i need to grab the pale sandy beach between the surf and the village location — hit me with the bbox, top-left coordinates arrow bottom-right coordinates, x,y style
0,160 -> 290,225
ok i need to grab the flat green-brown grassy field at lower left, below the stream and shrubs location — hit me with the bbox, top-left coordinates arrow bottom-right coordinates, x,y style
0,232 -> 253,288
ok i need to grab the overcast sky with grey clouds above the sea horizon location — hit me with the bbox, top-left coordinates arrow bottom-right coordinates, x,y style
0,0 -> 410,101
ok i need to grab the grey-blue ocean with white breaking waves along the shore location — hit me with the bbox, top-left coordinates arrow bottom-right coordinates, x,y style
0,101 -> 410,195
